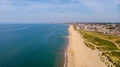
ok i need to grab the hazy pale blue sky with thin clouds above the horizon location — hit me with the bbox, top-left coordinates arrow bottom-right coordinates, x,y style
0,0 -> 120,23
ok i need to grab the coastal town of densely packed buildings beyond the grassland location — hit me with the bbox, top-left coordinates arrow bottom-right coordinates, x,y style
77,23 -> 120,36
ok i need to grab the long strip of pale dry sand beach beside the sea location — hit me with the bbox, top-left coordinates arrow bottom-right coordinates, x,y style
66,25 -> 107,67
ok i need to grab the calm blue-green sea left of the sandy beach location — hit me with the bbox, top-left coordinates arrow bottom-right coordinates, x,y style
0,24 -> 68,67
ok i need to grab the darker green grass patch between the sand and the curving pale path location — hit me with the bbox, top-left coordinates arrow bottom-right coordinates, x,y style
81,31 -> 119,51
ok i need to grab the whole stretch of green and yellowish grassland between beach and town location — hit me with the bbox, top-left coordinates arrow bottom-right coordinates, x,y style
74,25 -> 120,67
